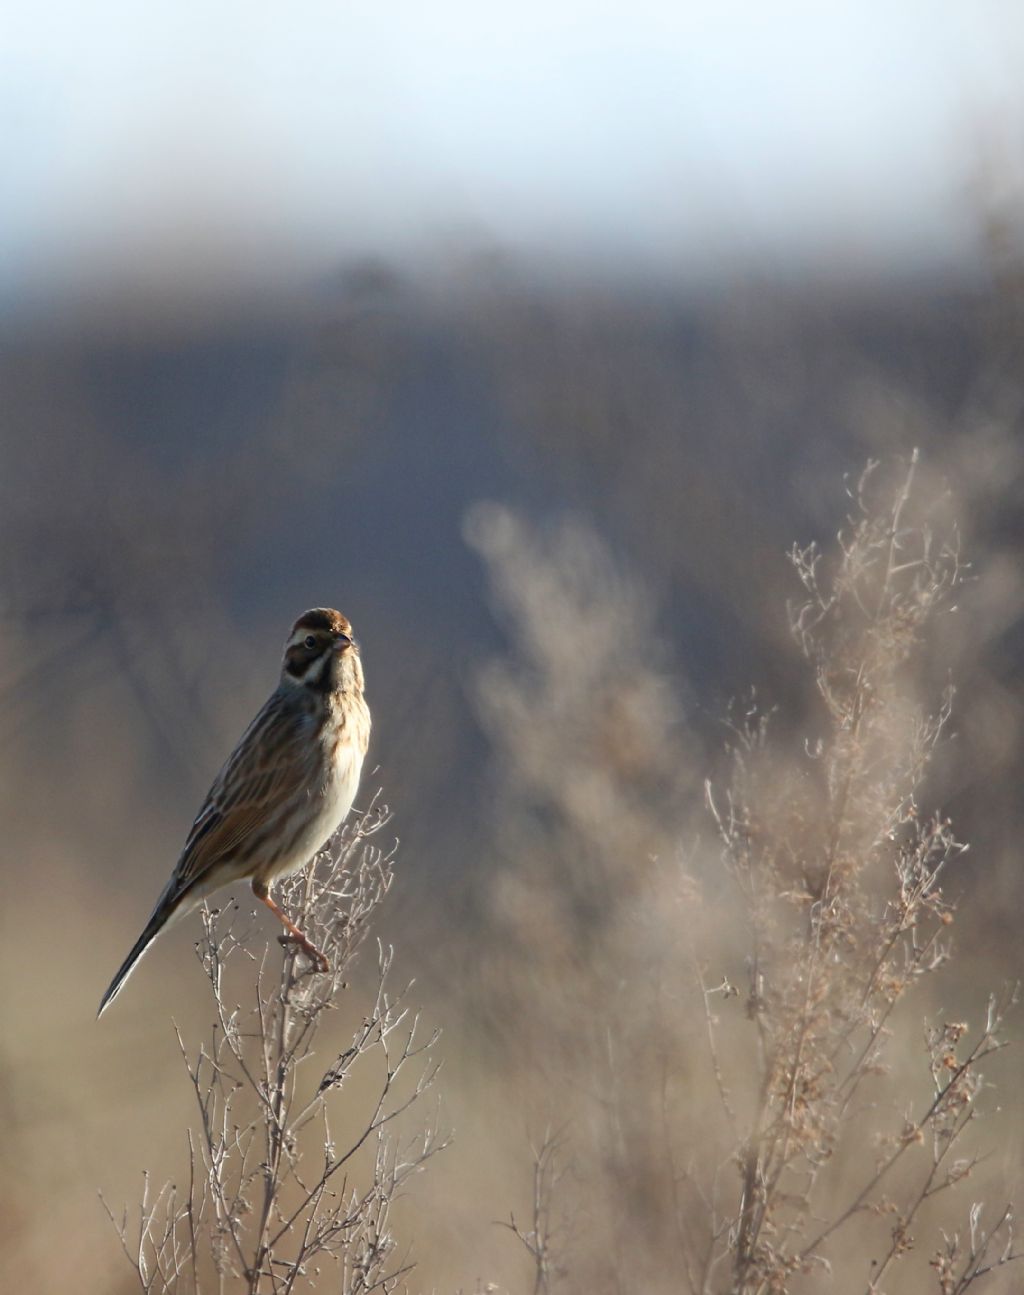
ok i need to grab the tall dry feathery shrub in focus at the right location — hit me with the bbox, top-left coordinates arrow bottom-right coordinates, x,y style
690,457 -> 1016,1292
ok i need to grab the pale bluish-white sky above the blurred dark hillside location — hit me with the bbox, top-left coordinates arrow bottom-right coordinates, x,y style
0,0 -> 1024,308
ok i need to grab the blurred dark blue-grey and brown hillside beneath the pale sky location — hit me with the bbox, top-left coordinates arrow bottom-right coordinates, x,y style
0,263 -> 1021,913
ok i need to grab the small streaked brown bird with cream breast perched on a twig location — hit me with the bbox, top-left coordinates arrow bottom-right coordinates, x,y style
97,607 -> 370,1017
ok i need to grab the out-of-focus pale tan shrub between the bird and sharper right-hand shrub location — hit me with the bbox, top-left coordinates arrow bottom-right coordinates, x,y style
467,504 -> 714,1291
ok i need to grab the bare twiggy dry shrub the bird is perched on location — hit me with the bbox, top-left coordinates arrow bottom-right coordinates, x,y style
104,805 -> 444,1295
